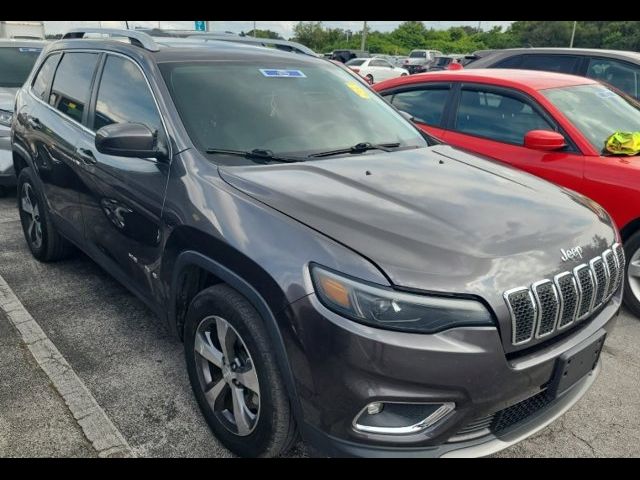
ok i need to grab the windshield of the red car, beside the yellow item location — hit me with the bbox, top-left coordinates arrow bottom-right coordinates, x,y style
541,85 -> 640,152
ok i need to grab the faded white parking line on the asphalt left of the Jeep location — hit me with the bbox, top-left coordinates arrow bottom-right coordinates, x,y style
0,275 -> 136,457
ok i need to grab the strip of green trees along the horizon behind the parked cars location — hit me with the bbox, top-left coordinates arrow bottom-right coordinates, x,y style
288,21 -> 640,55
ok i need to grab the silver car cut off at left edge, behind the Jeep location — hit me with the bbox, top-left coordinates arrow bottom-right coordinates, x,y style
0,39 -> 45,196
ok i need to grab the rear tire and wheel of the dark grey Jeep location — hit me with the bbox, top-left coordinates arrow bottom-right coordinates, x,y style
17,167 -> 74,262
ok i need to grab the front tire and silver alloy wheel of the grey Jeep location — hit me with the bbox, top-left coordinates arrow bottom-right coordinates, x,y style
184,284 -> 297,457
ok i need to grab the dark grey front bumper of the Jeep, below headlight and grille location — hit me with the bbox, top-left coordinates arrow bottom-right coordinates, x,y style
288,291 -> 621,457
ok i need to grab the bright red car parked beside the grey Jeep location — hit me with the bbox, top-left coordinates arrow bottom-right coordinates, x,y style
372,69 -> 640,316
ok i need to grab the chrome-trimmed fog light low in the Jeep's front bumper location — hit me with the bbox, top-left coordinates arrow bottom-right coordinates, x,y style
353,402 -> 455,435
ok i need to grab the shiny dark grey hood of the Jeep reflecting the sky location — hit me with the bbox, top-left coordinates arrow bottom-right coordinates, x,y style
220,145 -> 615,307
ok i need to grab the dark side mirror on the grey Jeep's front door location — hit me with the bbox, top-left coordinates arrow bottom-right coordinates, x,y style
95,123 -> 166,159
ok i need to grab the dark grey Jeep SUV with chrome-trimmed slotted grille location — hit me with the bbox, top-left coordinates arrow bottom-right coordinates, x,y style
12,29 -> 624,457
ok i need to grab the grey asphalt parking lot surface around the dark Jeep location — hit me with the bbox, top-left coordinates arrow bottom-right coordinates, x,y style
0,192 -> 640,457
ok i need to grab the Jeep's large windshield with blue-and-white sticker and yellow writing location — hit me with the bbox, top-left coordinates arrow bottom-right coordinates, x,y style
160,60 -> 427,160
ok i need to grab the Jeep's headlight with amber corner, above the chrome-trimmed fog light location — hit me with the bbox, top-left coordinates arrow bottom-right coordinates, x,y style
311,265 -> 495,333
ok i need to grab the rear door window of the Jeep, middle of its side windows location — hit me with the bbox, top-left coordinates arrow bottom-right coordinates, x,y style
49,53 -> 98,123
